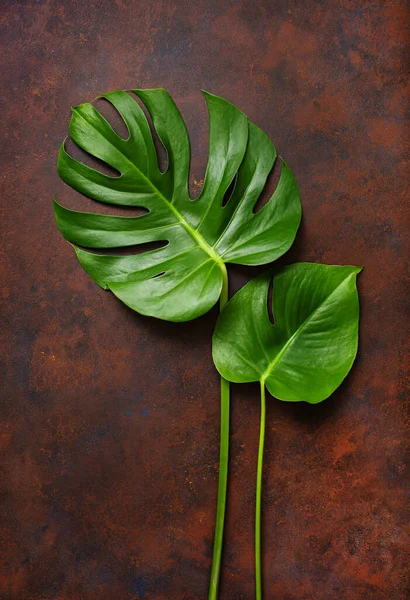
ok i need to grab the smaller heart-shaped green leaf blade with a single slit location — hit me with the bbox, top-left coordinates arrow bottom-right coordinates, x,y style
212,263 -> 361,403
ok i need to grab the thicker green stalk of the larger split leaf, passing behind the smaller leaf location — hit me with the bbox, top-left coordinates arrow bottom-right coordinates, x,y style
208,265 -> 229,600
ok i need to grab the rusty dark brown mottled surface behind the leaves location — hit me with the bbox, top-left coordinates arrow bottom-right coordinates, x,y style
0,0 -> 410,600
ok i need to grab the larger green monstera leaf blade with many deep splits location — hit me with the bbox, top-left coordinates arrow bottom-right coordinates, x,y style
54,89 -> 301,321
